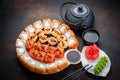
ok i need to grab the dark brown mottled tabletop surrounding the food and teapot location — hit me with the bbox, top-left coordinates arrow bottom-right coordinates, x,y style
0,0 -> 120,80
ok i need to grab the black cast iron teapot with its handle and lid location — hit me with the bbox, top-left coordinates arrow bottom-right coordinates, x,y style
60,2 -> 94,29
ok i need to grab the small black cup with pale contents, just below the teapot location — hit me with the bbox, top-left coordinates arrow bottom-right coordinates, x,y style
82,28 -> 100,45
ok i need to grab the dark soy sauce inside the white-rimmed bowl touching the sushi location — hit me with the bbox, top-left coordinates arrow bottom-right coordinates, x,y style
67,51 -> 80,62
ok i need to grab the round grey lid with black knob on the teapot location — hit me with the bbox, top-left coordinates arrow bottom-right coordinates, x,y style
71,4 -> 90,17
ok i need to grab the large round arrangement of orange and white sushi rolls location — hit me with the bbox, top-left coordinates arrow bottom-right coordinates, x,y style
16,19 -> 79,74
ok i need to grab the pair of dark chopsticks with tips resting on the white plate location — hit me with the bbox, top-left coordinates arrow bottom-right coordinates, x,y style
61,64 -> 93,80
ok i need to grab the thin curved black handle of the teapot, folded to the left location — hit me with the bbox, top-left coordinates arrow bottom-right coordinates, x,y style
60,2 -> 86,28
